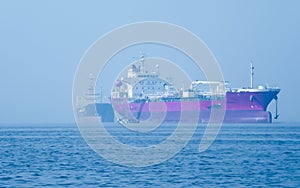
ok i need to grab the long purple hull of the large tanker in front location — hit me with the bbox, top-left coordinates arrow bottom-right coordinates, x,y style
112,89 -> 280,123
